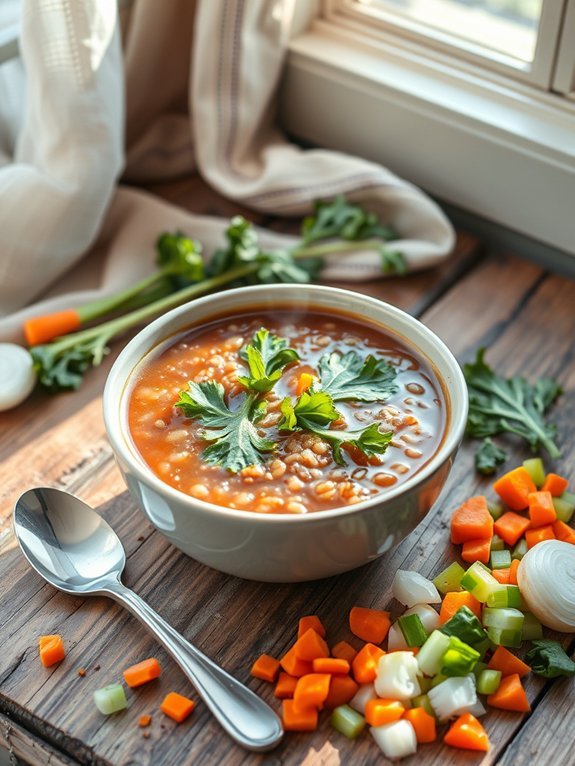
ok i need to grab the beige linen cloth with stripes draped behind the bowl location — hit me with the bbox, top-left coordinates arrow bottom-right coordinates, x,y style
0,0 -> 454,340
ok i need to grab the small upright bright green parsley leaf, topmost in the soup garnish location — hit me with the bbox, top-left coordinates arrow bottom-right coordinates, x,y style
238,327 -> 299,393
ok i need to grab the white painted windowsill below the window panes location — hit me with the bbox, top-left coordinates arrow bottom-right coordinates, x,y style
281,21 -> 575,254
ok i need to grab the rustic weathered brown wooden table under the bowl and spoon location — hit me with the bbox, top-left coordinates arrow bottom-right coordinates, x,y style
0,179 -> 575,766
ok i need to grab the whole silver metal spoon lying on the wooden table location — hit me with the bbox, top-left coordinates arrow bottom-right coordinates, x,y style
14,488 -> 283,751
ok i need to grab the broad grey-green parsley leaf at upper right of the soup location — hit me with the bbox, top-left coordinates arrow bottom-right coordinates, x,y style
319,351 -> 397,402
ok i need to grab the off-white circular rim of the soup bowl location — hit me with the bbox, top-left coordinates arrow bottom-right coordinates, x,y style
103,283 -> 469,524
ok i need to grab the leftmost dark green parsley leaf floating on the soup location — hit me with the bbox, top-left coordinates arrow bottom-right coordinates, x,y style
176,380 -> 275,473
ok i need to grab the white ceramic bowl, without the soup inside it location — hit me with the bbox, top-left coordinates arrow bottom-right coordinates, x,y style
104,284 -> 468,582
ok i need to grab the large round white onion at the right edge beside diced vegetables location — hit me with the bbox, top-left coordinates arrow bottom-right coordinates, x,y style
517,540 -> 575,633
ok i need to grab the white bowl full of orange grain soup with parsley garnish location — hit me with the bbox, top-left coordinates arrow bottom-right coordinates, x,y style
104,285 -> 467,582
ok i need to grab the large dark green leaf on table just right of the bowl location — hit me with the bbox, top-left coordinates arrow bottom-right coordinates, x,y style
463,348 -> 561,458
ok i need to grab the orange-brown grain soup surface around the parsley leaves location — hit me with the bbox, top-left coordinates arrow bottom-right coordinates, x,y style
129,307 -> 447,514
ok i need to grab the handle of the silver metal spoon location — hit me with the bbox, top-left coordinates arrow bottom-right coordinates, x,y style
106,582 -> 283,751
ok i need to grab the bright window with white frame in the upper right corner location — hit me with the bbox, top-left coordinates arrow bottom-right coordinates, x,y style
326,0 -> 575,97
